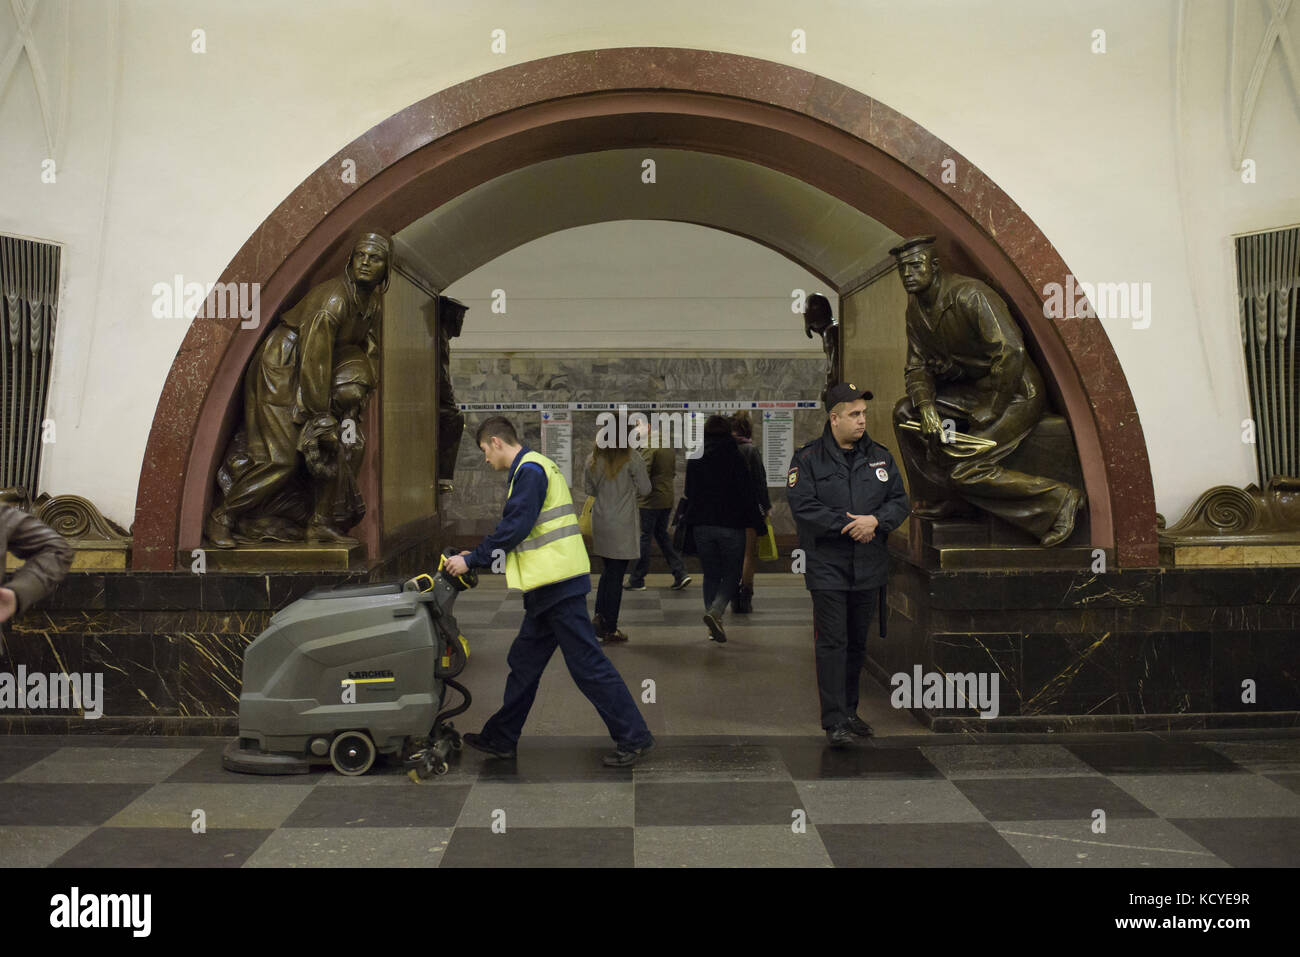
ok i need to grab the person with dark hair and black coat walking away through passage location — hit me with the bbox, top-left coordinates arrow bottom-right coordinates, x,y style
681,415 -> 767,642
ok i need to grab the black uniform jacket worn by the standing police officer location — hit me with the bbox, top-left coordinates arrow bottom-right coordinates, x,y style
785,423 -> 911,592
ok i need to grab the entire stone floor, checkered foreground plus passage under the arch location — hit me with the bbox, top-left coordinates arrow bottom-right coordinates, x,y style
0,576 -> 1300,867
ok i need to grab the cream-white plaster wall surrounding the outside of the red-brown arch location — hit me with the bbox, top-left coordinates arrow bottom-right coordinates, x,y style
0,0 -> 1300,523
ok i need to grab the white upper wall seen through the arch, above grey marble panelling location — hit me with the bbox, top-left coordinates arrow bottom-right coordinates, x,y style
445,220 -> 836,358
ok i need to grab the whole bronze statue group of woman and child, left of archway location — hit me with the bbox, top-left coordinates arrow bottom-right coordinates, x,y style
203,233 -> 393,547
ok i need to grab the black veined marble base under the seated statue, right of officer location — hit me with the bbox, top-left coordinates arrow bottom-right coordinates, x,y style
868,554 -> 1300,733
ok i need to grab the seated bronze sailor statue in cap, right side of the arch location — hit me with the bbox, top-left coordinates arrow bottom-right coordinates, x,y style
889,235 -> 1084,546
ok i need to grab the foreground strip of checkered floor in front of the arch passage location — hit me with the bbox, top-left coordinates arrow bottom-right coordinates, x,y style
0,735 -> 1300,867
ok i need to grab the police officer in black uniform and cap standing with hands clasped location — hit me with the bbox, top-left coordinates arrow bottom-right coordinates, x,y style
785,382 -> 910,748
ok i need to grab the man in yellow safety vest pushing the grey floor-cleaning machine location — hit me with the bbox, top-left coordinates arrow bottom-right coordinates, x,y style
447,415 -> 654,767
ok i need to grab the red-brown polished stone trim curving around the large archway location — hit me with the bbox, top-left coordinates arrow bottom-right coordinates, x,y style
133,48 -> 1157,570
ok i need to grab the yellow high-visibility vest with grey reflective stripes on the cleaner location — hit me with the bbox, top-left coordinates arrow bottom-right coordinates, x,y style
506,451 -> 592,592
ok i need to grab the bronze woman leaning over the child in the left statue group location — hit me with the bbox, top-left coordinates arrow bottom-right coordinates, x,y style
204,233 -> 393,547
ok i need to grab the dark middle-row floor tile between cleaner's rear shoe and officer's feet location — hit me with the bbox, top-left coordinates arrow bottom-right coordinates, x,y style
636,781 -> 803,827
